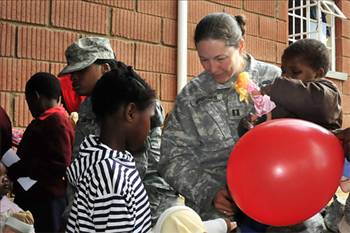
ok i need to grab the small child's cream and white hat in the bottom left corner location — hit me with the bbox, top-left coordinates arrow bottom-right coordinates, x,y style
2,211 -> 34,233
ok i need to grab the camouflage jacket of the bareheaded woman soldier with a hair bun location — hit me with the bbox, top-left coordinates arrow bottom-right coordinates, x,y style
159,55 -> 281,220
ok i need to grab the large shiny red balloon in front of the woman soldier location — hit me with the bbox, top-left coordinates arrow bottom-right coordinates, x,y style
227,119 -> 344,226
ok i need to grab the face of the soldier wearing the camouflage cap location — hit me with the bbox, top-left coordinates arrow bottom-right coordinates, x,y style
72,64 -> 103,96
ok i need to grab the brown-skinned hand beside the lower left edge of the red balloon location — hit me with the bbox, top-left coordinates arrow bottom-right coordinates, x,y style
213,188 -> 234,217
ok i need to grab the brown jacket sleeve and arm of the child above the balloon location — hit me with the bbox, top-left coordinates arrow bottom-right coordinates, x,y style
263,78 -> 341,128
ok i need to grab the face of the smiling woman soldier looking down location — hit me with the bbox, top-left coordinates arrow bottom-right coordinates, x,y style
196,39 -> 243,83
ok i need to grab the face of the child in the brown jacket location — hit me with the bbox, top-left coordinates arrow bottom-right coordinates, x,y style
281,57 -> 323,81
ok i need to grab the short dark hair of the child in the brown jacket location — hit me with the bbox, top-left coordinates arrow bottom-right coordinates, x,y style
282,39 -> 330,74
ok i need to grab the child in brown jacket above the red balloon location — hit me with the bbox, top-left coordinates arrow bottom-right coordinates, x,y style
262,39 -> 342,130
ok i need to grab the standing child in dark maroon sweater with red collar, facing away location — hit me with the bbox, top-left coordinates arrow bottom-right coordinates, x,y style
8,72 -> 74,232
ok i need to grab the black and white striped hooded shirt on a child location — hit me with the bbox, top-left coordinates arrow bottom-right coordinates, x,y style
66,135 -> 151,232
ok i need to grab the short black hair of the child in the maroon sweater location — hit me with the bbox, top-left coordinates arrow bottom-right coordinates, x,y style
25,72 -> 61,100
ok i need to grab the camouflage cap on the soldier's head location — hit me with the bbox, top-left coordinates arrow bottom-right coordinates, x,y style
59,37 -> 115,76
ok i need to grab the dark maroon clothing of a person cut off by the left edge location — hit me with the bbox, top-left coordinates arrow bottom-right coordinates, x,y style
0,106 -> 12,158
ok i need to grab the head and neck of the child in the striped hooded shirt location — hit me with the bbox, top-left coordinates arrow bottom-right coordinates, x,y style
91,62 -> 155,152
